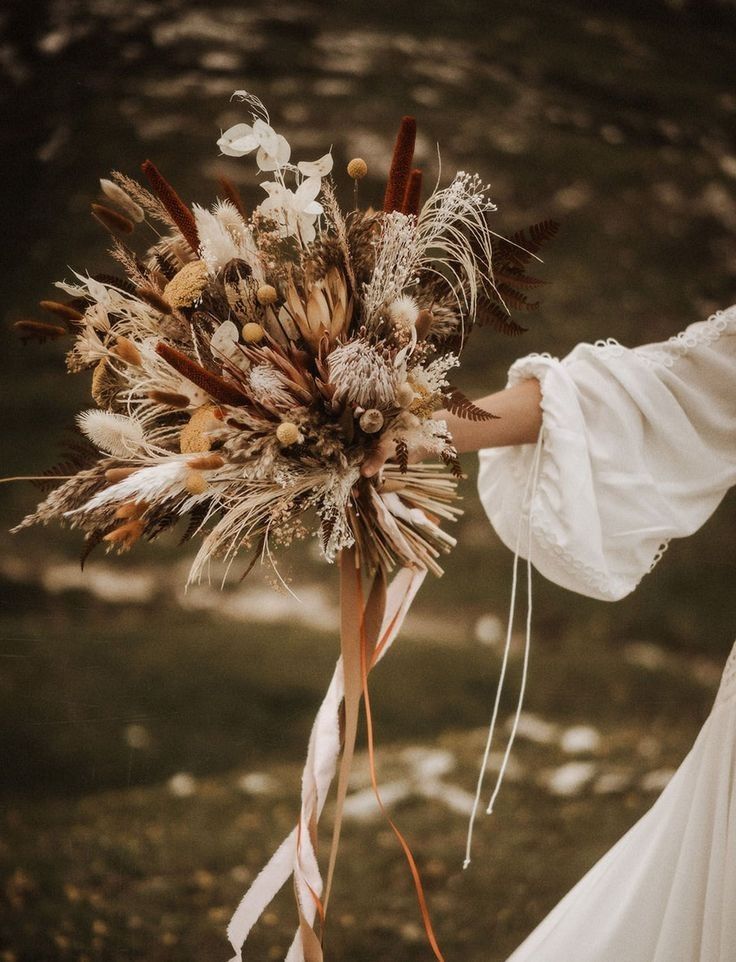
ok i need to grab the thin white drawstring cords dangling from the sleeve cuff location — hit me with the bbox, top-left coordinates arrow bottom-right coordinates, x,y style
463,427 -> 544,869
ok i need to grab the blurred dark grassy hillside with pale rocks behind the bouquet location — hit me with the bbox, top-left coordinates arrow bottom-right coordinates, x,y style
0,0 -> 736,962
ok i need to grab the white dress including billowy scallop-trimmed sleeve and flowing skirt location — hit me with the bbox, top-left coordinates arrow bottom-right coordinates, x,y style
478,306 -> 736,962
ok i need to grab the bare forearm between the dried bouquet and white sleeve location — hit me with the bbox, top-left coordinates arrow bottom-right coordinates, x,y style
434,378 -> 542,453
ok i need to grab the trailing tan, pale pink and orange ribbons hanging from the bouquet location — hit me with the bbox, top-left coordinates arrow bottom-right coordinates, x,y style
227,549 -> 428,962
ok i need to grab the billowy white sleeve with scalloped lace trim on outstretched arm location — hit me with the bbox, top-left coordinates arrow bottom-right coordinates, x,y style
478,306 -> 736,601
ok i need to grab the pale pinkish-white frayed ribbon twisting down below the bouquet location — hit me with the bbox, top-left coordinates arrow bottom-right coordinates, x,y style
227,568 -> 427,962
